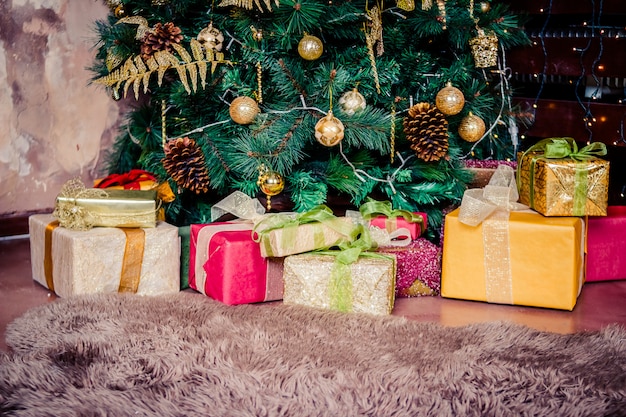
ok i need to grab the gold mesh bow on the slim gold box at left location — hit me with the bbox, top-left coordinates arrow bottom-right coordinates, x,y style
53,178 -> 108,230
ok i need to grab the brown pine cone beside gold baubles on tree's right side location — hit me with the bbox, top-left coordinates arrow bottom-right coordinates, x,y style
404,103 -> 448,162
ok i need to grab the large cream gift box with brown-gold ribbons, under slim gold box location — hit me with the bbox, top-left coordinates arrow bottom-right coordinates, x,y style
29,214 -> 180,297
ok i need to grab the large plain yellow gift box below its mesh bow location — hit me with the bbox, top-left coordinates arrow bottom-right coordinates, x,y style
441,209 -> 584,310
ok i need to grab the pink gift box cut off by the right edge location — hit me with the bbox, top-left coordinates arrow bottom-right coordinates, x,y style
586,206 -> 626,282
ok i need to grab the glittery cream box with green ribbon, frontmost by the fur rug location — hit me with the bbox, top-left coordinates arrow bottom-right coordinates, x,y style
283,253 -> 396,315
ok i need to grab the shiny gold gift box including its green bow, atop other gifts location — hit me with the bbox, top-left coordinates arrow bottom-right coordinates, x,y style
517,138 -> 609,216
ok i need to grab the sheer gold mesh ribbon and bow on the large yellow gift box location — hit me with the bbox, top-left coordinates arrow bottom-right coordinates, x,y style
459,165 -> 528,304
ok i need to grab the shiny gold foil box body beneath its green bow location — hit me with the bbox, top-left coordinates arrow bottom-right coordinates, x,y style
518,152 -> 609,216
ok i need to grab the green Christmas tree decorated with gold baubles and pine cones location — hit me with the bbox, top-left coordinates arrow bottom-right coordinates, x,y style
93,0 -> 528,237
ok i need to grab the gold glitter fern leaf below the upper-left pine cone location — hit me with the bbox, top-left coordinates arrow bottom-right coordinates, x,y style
93,44 -> 232,99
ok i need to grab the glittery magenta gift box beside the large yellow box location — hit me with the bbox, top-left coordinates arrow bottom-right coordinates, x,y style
378,238 -> 441,297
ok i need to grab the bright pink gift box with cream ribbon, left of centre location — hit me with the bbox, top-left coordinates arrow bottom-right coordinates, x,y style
189,222 -> 283,305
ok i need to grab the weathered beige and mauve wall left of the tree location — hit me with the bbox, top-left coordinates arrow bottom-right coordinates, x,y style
0,0 -> 121,215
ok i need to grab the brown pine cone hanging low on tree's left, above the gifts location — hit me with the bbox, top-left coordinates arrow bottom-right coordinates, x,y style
161,137 -> 209,194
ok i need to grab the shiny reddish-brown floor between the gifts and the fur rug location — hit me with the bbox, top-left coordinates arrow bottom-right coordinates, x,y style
0,236 -> 626,351
